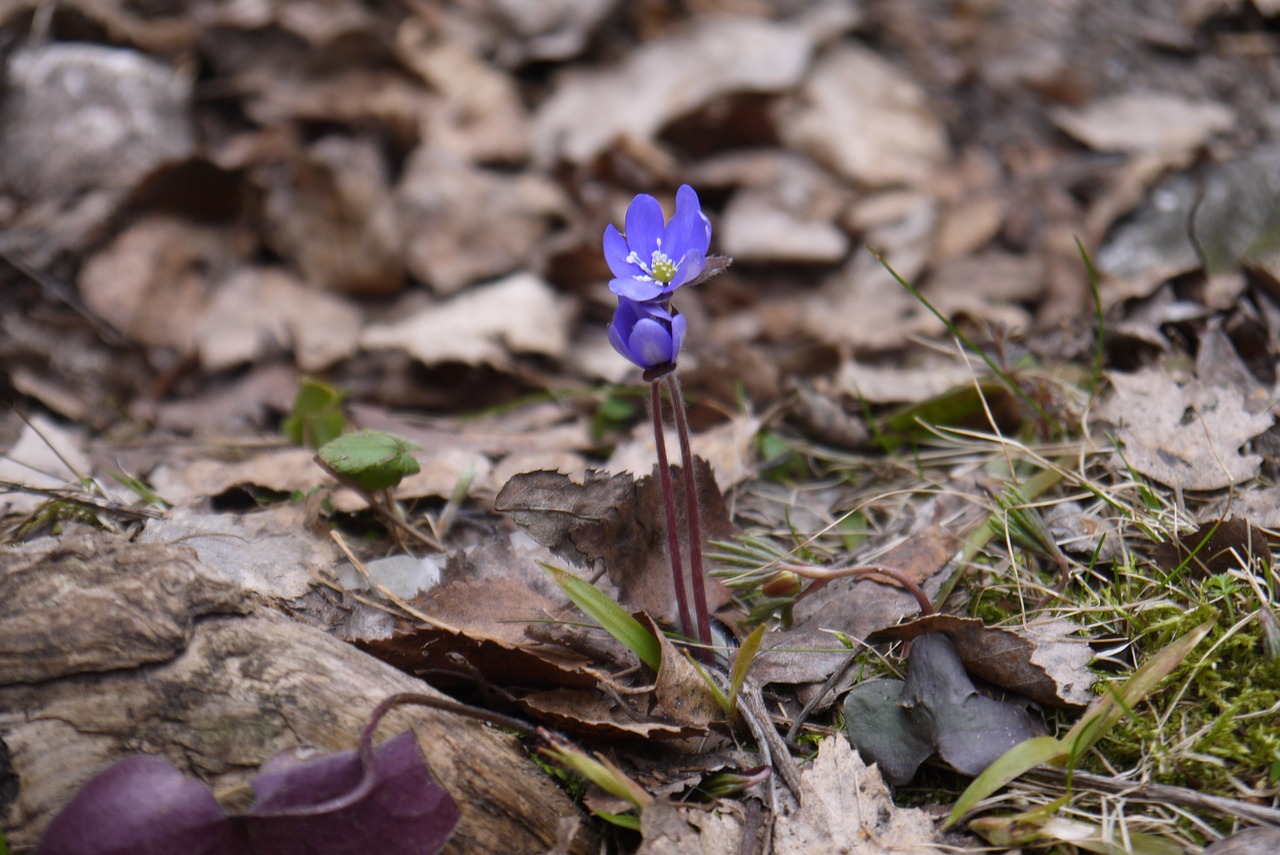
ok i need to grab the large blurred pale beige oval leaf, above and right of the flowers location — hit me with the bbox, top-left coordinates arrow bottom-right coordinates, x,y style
777,44 -> 947,187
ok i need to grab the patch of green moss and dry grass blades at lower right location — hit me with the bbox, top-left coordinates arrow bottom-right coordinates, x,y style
732,300 -> 1280,846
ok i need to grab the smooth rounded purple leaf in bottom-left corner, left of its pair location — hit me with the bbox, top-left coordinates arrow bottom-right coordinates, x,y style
36,756 -> 244,855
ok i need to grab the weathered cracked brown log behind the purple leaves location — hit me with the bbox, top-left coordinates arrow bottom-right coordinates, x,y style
0,532 -> 591,852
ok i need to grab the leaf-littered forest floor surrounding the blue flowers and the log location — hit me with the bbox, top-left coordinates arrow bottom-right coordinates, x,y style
0,0 -> 1280,852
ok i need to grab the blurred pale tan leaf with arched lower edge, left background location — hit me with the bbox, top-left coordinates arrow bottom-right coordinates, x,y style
193,268 -> 360,371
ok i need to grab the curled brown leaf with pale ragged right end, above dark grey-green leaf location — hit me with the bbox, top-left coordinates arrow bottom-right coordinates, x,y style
867,614 -> 1094,707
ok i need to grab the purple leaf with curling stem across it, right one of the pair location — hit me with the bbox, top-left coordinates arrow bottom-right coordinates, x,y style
244,733 -> 460,855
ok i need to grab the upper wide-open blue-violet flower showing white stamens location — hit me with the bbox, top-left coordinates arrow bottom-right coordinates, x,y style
604,184 -> 712,302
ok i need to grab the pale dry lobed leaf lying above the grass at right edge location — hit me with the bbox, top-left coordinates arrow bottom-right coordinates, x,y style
1096,367 -> 1274,490
